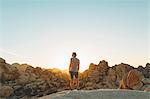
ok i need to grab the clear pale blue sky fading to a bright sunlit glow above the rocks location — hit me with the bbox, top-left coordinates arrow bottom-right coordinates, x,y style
0,0 -> 150,71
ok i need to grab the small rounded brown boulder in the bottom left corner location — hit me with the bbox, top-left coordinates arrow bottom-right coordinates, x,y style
0,86 -> 14,98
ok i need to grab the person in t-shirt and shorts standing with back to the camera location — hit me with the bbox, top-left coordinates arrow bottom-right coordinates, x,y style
69,52 -> 80,89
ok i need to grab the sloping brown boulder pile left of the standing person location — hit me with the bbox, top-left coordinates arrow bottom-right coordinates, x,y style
0,58 -> 69,98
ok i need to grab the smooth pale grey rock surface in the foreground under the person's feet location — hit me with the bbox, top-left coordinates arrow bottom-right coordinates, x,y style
39,89 -> 150,99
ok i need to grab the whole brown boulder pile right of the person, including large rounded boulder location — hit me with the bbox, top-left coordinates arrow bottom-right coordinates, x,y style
80,60 -> 150,91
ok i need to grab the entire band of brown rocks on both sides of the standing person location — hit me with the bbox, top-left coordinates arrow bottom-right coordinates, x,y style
0,58 -> 150,98
